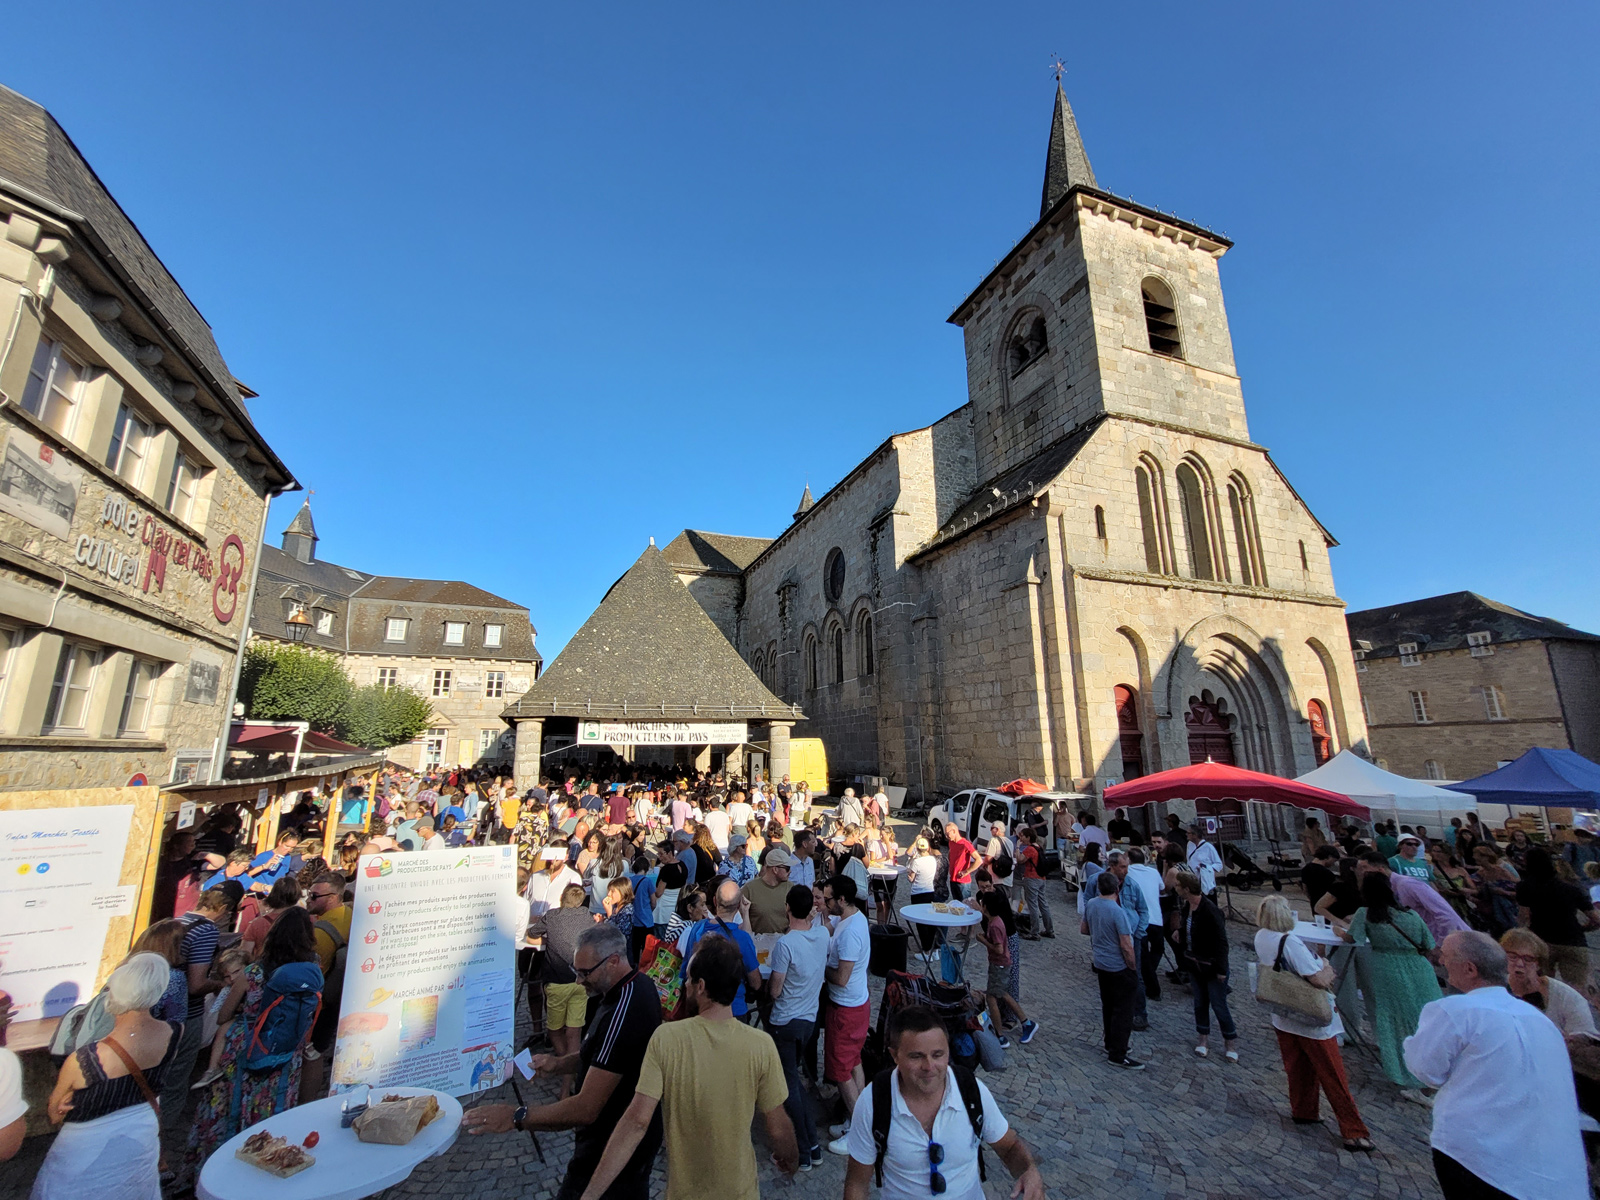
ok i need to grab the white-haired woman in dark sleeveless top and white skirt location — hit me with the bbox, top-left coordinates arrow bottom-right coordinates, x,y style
30,954 -> 182,1200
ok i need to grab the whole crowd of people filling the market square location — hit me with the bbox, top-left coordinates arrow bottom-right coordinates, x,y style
12,770 -> 1600,1200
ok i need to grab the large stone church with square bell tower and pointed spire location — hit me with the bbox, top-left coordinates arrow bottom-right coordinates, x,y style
553,88 -> 1366,797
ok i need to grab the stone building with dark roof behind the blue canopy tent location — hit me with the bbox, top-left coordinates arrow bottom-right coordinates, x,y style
1346,592 -> 1600,779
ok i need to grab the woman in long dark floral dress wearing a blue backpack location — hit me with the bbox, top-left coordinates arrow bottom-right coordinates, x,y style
189,909 -> 317,1171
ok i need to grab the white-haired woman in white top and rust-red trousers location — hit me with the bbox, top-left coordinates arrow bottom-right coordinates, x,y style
1256,896 -> 1373,1154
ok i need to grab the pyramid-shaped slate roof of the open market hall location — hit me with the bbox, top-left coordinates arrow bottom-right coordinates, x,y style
501,546 -> 803,720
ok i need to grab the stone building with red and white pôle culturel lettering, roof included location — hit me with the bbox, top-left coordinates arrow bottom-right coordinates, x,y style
0,88 -> 294,790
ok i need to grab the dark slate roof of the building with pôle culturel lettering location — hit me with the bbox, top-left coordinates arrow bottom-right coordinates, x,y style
0,85 -> 294,485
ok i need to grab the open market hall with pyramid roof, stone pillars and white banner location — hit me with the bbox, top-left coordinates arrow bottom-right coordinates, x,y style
501,544 -> 805,787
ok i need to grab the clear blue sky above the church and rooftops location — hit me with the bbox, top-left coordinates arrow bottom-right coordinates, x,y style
0,0 -> 1600,659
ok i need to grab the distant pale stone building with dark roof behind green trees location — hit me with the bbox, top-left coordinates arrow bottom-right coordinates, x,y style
250,499 -> 542,768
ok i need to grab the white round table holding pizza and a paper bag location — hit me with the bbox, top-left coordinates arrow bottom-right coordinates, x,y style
195,1088 -> 461,1200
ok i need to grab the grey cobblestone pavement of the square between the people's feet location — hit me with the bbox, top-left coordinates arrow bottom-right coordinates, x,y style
390,882 -> 1440,1200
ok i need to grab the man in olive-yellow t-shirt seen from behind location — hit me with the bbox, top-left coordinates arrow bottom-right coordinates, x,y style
582,936 -> 800,1200
